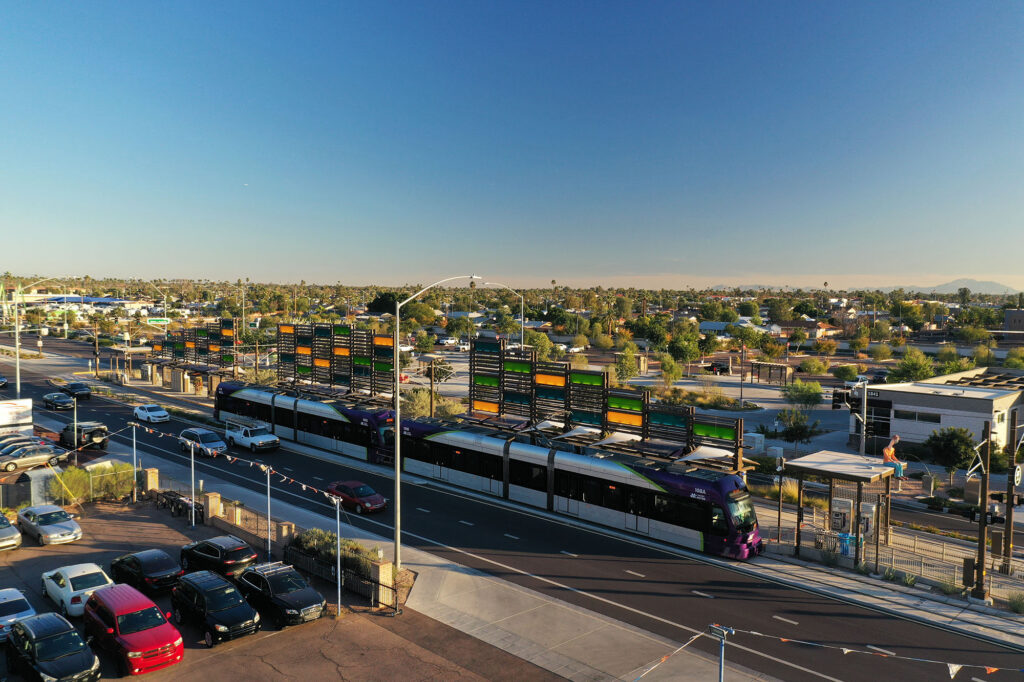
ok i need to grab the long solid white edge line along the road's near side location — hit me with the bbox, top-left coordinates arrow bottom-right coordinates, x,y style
108,430 -> 843,682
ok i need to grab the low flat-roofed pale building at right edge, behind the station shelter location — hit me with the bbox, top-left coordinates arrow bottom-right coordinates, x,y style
850,368 -> 1024,447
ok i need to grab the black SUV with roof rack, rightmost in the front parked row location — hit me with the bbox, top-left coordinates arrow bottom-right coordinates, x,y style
237,561 -> 327,626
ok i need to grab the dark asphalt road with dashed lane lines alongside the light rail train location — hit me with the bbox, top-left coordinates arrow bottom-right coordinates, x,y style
8,367 -> 1022,682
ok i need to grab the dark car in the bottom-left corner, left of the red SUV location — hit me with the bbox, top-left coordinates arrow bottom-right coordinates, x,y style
7,613 -> 99,682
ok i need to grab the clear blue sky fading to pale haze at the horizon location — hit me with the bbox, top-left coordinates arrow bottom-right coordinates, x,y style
0,0 -> 1024,289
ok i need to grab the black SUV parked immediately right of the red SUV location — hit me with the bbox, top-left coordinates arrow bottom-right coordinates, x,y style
171,570 -> 259,646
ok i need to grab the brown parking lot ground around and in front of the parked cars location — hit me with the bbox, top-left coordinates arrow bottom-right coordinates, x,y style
0,503 -> 558,682
